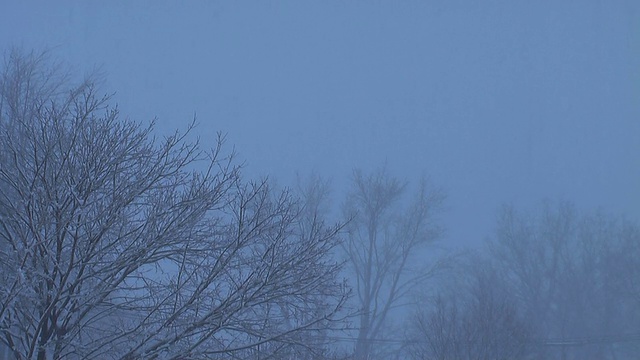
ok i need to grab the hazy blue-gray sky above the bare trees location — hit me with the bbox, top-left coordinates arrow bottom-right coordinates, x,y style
0,0 -> 640,244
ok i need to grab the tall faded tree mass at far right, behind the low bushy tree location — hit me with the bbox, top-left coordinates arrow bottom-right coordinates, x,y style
491,203 -> 640,360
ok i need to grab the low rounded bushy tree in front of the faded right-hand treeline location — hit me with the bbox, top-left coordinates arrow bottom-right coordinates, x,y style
406,259 -> 532,360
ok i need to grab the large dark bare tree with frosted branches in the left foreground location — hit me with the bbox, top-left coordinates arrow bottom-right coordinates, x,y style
0,52 -> 346,360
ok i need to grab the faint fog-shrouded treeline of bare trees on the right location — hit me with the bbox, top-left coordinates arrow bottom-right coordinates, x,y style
408,202 -> 640,360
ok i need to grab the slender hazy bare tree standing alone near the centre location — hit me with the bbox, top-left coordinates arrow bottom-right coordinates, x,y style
344,169 -> 444,359
